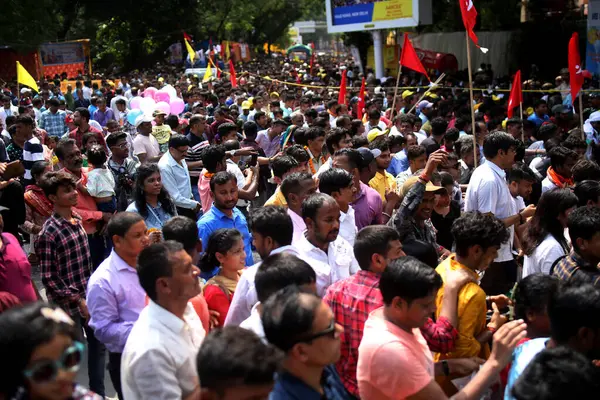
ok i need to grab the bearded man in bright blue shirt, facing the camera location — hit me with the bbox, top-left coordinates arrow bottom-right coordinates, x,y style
197,171 -> 253,266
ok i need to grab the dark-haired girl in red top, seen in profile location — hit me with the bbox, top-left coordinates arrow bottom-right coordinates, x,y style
198,229 -> 246,326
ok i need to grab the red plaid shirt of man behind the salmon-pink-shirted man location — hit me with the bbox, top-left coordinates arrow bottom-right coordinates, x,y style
323,270 -> 458,397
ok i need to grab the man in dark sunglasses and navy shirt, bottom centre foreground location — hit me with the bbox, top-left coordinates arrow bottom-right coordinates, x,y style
262,286 -> 350,400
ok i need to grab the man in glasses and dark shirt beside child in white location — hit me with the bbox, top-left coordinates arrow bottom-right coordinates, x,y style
106,132 -> 139,211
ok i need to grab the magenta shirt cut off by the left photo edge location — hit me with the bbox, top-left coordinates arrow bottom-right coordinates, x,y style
0,233 -> 37,303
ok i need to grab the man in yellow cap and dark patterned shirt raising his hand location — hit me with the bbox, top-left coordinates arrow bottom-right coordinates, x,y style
389,150 -> 449,254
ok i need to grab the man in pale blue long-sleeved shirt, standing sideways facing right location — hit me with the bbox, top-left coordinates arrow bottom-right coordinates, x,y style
158,134 -> 202,221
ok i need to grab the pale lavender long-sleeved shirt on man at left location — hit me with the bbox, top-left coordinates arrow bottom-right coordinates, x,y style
87,250 -> 146,353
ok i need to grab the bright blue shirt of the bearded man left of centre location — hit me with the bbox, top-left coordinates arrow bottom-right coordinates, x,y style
197,204 -> 254,266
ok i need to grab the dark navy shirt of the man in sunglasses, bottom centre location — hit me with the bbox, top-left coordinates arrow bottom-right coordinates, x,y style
269,365 -> 352,400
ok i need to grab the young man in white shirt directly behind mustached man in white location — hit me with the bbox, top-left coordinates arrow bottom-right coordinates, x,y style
319,168 -> 358,247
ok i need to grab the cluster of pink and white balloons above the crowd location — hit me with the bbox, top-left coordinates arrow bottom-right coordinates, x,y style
127,86 -> 185,116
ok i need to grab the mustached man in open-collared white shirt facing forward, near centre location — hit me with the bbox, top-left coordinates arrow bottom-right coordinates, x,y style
294,193 -> 358,283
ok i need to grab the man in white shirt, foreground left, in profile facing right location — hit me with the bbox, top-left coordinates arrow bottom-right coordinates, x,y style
121,240 -> 205,400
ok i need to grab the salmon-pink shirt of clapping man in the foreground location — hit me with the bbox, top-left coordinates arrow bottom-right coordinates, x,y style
356,307 -> 434,400
